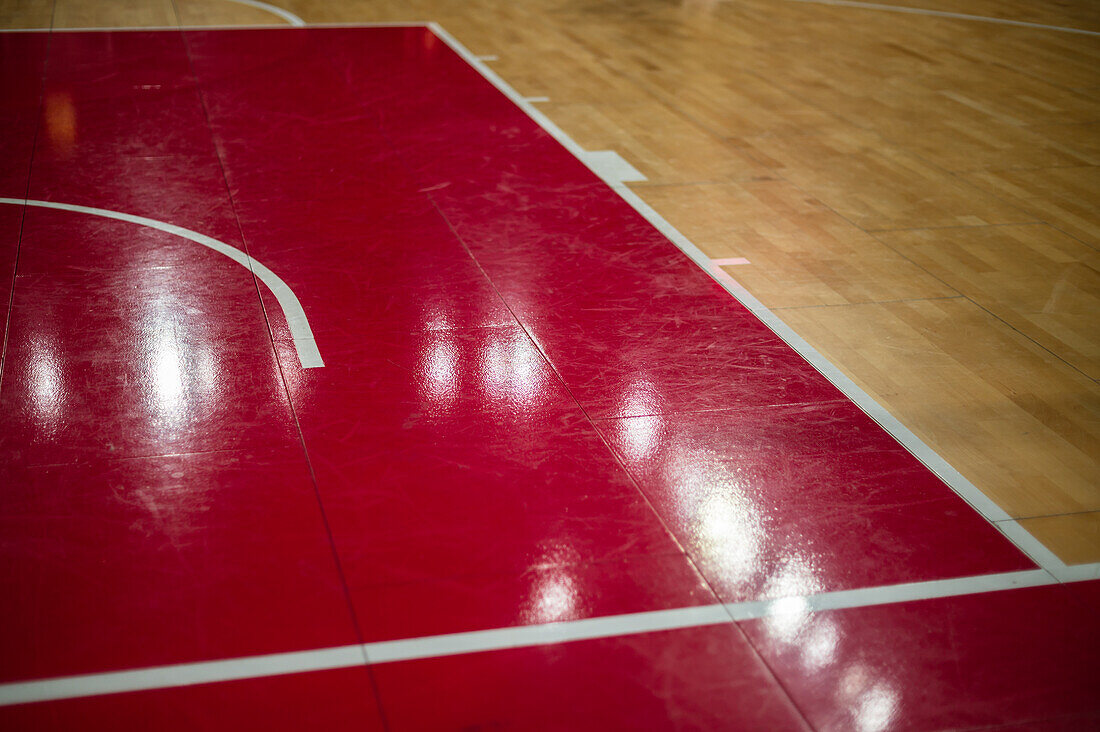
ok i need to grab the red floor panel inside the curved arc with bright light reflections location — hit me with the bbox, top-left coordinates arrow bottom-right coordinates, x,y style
0,250 -> 299,466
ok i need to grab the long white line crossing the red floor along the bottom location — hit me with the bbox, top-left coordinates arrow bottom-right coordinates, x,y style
0,569 -> 1055,707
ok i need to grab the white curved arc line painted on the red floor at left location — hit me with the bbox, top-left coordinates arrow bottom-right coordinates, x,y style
0,198 -> 325,369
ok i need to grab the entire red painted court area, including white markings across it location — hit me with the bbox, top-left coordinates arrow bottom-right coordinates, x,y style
0,26 -> 1100,732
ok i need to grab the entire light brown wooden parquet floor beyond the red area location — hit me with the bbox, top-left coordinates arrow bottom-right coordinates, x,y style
0,0 -> 1100,564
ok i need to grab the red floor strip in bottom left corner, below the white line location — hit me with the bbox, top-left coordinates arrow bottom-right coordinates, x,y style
0,668 -> 384,732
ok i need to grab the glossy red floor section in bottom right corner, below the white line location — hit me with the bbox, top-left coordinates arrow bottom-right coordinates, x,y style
741,587 -> 1100,730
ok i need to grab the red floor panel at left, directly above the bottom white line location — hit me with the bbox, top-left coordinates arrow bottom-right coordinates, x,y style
0,449 -> 356,680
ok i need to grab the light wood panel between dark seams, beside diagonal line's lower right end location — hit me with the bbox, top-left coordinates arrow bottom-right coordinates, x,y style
779,298 -> 1100,517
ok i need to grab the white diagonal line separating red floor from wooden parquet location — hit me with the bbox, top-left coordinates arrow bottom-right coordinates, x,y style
428,23 -> 1100,577
